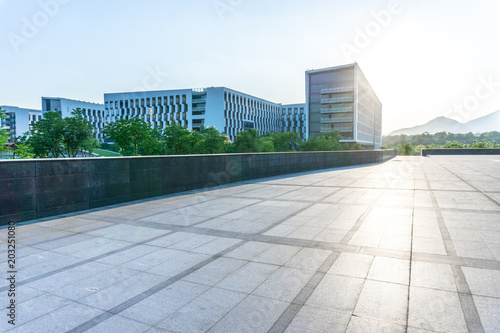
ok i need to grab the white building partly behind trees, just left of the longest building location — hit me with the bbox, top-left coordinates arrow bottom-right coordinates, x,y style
42,97 -> 105,142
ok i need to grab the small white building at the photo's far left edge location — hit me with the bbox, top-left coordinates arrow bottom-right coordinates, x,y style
0,105 -> 42,142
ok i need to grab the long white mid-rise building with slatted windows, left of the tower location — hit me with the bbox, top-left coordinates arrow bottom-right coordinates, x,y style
104,87 -> 292,141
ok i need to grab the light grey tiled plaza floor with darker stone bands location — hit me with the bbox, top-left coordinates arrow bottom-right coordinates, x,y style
0,156 -> 500,333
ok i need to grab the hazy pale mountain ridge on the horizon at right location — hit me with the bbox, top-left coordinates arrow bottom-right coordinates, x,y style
389,110 -> 500,135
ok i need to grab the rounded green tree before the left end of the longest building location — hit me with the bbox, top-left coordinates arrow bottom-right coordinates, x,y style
103,117 -> 150,156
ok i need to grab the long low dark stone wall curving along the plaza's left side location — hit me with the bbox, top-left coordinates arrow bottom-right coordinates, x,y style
0,150 -> 395,225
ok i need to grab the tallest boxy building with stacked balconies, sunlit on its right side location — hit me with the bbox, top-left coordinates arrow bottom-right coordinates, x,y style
306,63 -> 382,149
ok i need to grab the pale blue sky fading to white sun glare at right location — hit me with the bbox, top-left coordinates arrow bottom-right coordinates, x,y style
0,0 -> 500,134
